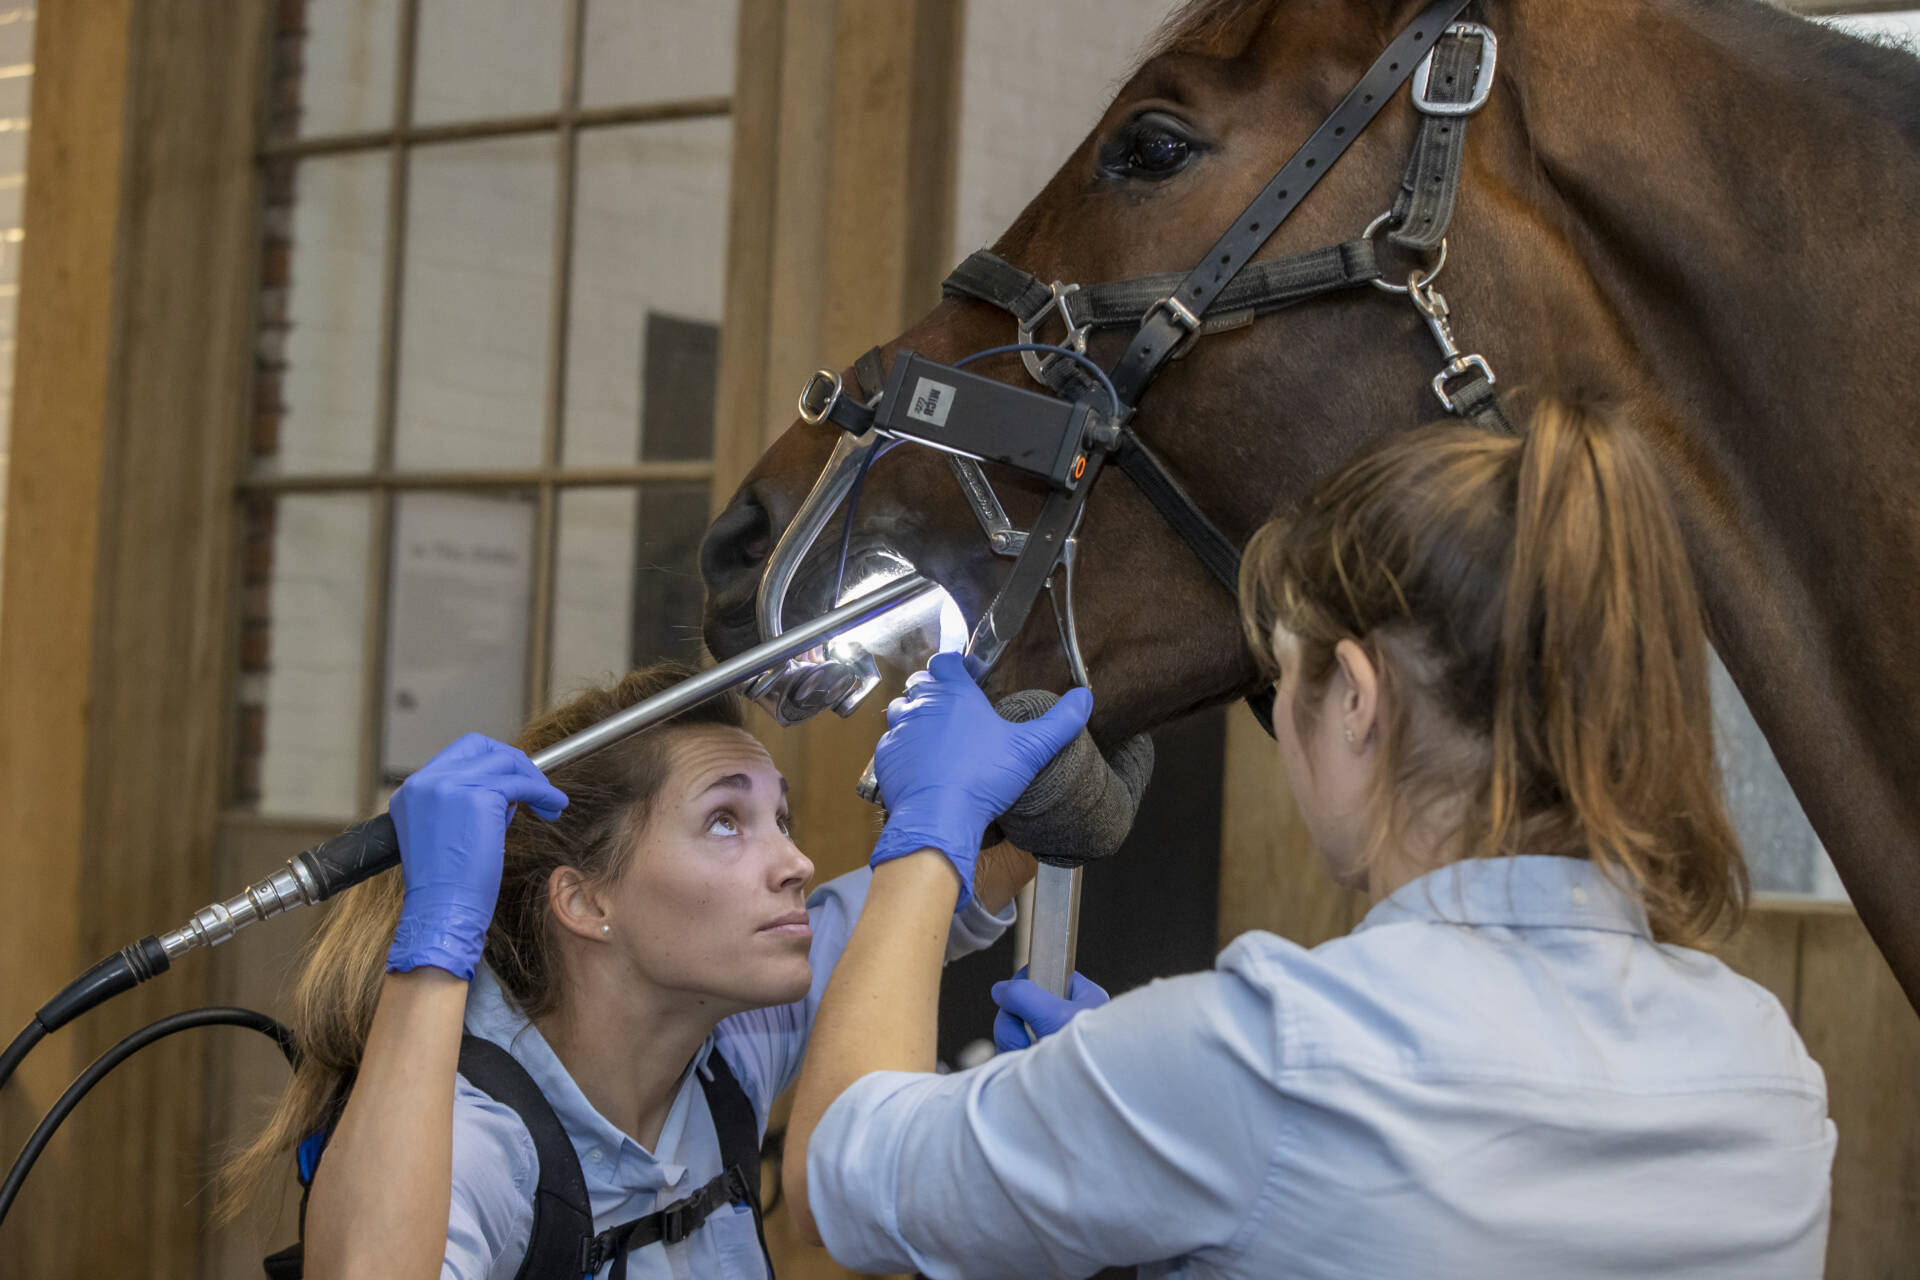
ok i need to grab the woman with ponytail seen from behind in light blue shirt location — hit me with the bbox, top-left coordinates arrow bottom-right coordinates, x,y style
785,405 -> 1834,1280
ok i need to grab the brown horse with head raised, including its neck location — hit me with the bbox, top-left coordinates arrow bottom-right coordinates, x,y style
703,0 -> 1920,1006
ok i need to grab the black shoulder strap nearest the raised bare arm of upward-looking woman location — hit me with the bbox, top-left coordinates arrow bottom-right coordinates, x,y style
461,1036 -> 593,1280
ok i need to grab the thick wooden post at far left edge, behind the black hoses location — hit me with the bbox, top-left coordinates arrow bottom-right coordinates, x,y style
0,0 -> 265,1276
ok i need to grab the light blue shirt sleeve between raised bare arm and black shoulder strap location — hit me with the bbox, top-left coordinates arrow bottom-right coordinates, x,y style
440,1080 -> 540,1280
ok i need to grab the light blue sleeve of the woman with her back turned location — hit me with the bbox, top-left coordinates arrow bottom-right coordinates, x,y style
806,973 -> 1283,1280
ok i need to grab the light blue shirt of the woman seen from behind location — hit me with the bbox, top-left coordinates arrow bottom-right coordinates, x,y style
806,858 -> 1834,1280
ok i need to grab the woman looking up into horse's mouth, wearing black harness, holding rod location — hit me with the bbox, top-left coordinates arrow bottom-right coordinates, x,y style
225,664 -> 1085,1280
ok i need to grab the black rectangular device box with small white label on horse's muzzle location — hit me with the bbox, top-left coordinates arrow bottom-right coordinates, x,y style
876,351 -> 1092,489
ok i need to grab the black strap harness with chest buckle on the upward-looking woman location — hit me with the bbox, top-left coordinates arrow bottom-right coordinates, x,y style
267,1034 -> 774,1280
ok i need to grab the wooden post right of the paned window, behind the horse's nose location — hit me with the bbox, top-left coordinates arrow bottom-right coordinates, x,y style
714,0 -> 962,1280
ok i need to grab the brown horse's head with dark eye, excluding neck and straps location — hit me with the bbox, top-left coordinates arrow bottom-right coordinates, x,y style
701,0 -> 1597,737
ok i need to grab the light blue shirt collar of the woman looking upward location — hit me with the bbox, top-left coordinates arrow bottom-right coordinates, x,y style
467,961 -> 714,1190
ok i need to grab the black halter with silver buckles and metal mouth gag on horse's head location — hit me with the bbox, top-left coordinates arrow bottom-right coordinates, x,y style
751,0 -> 1513,736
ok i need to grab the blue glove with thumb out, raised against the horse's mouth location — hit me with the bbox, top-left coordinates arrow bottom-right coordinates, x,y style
870,652 -> 1092,906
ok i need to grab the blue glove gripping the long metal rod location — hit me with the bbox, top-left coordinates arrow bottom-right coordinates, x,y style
386,733 -> 566,979
